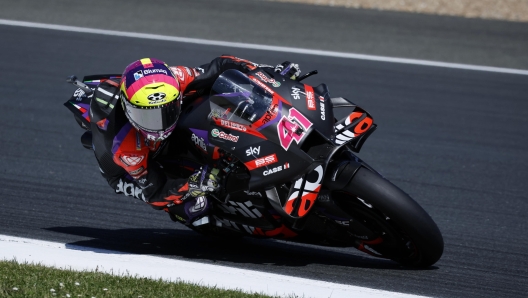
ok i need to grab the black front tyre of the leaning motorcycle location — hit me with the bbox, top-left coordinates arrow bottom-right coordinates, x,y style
329,167 -> 444,268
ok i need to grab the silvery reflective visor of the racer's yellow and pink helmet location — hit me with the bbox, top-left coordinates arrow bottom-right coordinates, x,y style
124,99 -> 180,131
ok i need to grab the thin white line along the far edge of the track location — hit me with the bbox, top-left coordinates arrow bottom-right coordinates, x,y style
0,19 -> 528,75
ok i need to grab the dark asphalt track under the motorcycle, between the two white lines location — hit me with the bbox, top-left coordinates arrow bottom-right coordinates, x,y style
0,2 -> 528,297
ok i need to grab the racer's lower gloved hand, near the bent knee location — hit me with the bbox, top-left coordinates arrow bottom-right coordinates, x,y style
188,166 -> 221,198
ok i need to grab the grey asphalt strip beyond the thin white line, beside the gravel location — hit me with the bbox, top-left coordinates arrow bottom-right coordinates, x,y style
0,0 -> 528,69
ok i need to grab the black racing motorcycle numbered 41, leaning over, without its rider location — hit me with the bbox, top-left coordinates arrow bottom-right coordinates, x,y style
65,68 -> 444,268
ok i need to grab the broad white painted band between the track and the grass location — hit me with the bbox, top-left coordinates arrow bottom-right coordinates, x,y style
0,235 -> 423,298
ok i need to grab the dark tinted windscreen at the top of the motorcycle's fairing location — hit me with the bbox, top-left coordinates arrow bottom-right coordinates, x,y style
209,69 -> 272,124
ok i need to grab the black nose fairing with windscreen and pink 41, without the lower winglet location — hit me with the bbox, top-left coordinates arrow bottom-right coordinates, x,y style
209,69 -> 333,189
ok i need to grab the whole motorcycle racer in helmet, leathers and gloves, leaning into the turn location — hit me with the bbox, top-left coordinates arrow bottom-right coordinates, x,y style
90,56 -> 300,226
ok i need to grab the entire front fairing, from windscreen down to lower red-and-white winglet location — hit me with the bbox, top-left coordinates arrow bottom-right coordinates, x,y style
178,69 -> 374,218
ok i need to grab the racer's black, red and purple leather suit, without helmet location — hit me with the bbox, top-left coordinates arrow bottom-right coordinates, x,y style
90,56 -> 258,224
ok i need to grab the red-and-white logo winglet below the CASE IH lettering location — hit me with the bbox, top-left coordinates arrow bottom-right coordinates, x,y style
284,165 -> 323,217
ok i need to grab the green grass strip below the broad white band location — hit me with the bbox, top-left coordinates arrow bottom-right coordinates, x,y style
0,261 -> 282,298
